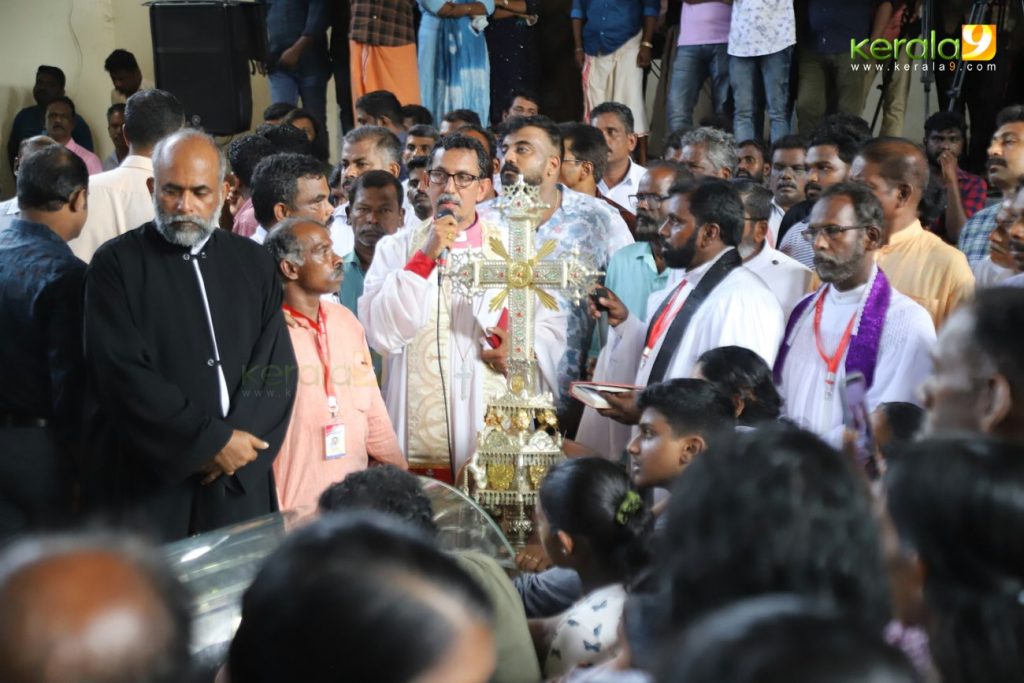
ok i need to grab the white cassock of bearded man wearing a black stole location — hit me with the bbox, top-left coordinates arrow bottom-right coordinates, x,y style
577,248 -> 785,460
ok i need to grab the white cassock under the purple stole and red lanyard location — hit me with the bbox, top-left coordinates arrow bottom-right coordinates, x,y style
779,268 -> 935,446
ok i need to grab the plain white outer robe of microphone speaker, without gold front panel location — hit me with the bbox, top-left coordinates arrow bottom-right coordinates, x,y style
358,222 -> 567,470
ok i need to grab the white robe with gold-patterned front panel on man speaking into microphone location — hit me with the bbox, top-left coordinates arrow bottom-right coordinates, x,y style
358,221 -> 567,471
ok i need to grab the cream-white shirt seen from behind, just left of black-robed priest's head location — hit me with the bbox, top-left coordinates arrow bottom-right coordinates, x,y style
68,155 -> 157,263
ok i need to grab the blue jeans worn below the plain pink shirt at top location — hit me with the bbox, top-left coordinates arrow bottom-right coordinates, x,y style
668,43 -> 729,132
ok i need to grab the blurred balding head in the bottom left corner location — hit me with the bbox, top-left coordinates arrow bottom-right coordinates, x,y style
0,539 -> 189,683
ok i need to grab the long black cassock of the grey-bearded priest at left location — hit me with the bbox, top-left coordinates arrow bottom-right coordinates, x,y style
82,223 -> 297,540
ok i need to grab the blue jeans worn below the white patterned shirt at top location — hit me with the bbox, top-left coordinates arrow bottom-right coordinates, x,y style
729,45 -> 794,141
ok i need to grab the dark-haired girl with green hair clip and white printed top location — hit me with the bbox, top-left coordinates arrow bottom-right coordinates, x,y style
530,458 -> 652,680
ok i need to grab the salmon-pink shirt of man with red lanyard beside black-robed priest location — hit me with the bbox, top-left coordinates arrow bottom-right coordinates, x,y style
273,301 -> 408,510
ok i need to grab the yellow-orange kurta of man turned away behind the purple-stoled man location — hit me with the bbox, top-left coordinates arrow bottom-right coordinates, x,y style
874,221 -> 974,330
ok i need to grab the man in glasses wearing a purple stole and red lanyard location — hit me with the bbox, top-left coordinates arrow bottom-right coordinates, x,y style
775,182 -> 935,446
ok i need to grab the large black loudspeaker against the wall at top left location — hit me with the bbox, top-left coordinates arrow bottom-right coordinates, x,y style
150,1 -> 267,135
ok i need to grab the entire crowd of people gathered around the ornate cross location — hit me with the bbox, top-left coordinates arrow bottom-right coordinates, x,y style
0,0 -> 1024,683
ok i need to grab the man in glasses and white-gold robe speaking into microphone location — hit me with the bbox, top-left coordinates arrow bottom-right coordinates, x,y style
358,134 -> 566,481
